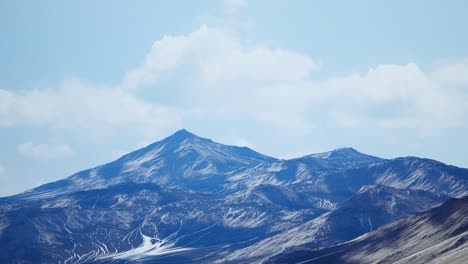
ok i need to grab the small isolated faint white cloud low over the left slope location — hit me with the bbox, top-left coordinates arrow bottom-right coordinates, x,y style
17,142 -> 73,160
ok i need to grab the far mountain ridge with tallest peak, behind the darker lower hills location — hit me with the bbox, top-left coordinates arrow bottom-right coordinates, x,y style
4,129 -> 468,198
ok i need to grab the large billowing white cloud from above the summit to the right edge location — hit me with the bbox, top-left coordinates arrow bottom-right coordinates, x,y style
123,26 -> 467,134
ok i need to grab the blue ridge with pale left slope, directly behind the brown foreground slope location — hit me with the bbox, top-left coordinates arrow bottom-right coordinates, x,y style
221,186 -> 447,263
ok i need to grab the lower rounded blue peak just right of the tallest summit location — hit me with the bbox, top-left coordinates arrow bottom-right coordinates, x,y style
226,148 -> 386,193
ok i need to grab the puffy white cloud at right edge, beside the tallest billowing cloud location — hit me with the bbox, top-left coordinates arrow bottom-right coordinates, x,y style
315,63 -> 468,129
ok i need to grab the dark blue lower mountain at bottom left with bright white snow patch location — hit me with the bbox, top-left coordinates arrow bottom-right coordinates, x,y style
0,183 -> 326,263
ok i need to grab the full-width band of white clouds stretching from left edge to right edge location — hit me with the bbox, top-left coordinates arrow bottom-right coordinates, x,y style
0,26 -> 468,146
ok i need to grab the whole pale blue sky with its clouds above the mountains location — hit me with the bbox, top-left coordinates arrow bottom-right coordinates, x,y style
0,0 -> 468,195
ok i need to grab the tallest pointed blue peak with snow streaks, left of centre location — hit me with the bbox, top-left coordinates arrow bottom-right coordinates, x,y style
16,130 -> 276,197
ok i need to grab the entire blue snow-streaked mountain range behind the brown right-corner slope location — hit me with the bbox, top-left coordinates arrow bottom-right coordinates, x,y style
0,130 -> 468,263
